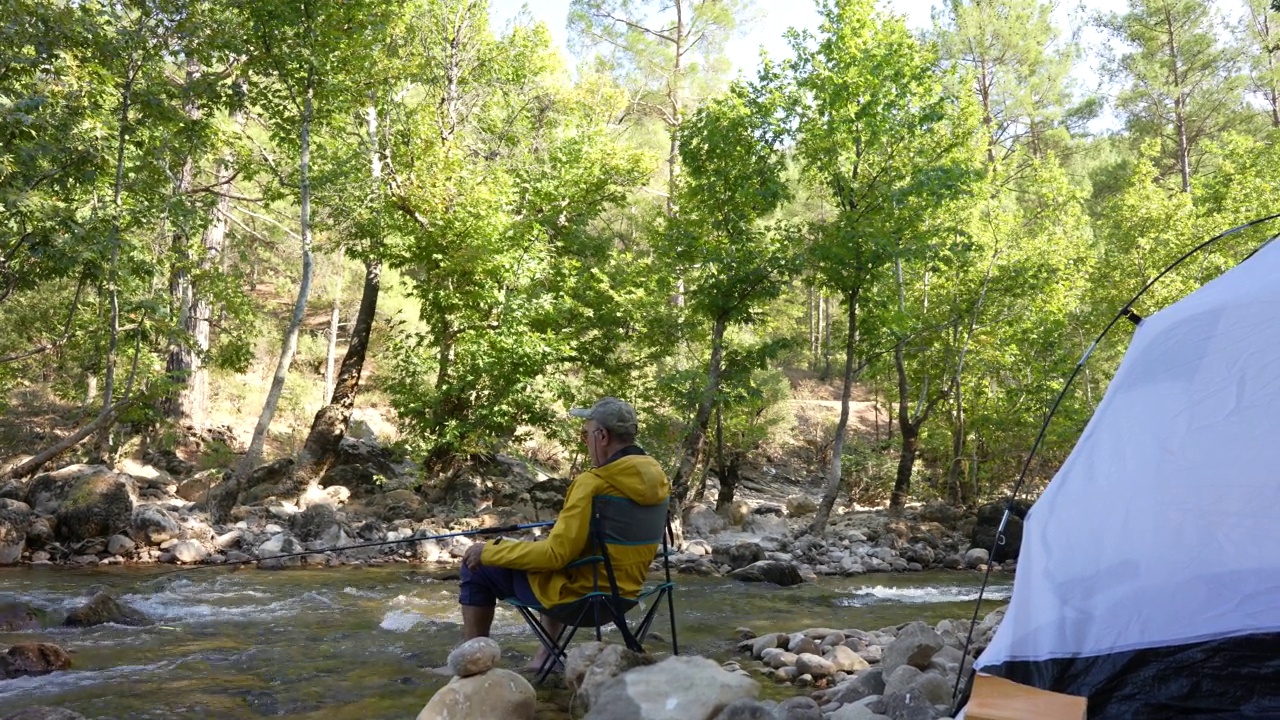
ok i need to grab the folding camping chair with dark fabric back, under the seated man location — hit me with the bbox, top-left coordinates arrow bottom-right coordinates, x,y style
503,495 -> 680,683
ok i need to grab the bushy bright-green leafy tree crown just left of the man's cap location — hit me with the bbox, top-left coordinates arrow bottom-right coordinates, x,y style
373,7 -> 641,462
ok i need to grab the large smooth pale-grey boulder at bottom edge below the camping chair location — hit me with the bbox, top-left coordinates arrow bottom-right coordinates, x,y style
586,655 -> 760,720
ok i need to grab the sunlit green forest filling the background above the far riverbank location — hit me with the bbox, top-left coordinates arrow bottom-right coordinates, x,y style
0,0 -> 1280,528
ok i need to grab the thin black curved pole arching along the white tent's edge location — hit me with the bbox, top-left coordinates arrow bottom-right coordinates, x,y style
951,213 -> 1280,715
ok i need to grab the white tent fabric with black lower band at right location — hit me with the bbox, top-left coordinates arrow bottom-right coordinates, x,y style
975,238 -> 1280,719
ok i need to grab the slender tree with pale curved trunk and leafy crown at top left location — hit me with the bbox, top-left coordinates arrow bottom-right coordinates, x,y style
237,0 -> 390,473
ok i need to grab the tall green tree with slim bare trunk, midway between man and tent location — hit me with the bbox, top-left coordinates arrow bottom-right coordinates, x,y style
792,0 -> 973,532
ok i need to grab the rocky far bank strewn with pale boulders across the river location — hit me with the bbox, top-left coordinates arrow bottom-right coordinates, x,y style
0,438 -> 1015,585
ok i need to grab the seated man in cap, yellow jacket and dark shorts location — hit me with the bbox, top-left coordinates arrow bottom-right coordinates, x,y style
458,397 -> 671,669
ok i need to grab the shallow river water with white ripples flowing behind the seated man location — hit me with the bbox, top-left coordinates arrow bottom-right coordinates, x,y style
0,566 -> 1010,720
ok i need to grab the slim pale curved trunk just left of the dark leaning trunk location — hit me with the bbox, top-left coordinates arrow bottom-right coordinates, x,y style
238,76 -> 315,475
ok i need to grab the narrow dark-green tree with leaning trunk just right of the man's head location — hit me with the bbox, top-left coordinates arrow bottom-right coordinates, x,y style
671,71 -> 796,502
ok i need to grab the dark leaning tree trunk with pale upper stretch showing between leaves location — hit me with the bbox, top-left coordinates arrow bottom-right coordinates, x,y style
300,105 -> 383,478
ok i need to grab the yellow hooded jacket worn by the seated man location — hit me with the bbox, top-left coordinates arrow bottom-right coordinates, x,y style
480,451 -> 671,607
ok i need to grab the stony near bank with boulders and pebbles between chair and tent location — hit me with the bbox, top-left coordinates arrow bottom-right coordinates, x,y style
417,599 -> 1004,720
